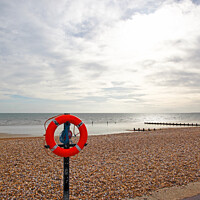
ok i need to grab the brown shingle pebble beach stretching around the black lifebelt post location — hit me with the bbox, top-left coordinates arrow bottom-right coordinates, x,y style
0,127 -> 200,200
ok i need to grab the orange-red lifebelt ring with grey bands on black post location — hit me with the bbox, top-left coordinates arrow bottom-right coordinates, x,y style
45,114 -> 88,157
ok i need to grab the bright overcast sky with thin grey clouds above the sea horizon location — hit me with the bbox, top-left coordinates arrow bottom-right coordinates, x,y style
0,0 -> 200,113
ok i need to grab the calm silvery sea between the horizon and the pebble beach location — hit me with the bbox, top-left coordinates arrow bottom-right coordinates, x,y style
0,113 -> 200,136
